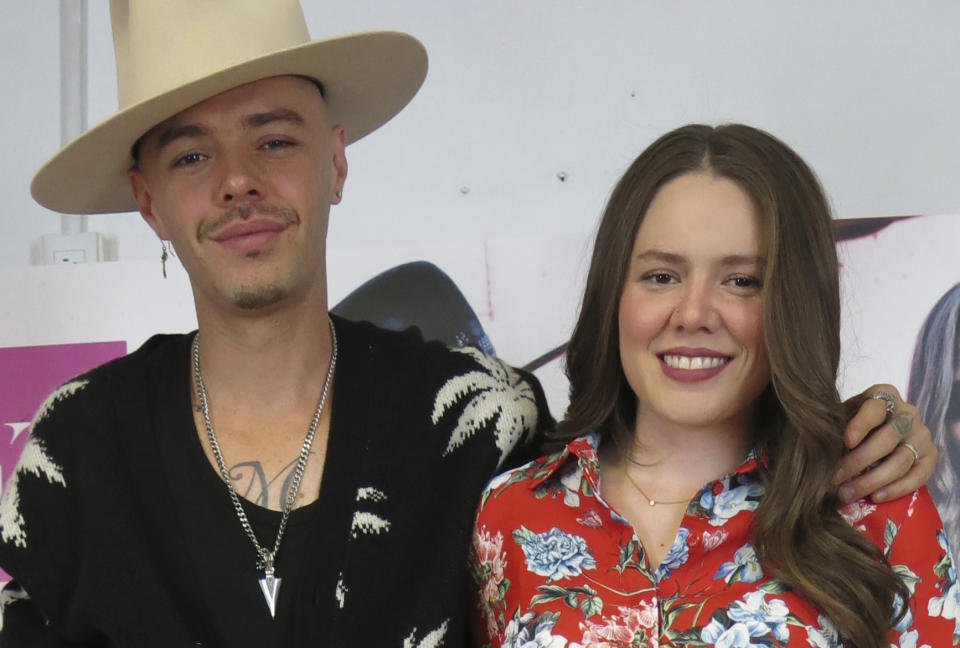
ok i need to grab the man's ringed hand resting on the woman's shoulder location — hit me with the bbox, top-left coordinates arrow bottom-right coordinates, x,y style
834,385 -> 939,502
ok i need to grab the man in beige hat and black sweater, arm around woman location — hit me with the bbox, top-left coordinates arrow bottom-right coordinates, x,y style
0,0 -> 935,647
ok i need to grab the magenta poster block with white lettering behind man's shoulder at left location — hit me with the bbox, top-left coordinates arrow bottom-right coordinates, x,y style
0,342 -> 127,582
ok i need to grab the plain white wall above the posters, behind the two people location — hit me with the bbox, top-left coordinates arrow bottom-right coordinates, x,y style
0,0 -> 960,268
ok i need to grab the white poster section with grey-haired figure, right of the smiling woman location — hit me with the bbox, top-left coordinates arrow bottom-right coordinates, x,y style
838,215 -> 960,549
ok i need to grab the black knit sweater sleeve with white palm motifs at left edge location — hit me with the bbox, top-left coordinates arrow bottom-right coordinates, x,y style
0,378 -> 91,647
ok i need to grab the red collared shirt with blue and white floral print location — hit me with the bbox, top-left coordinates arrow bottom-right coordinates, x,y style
470,434 -> 960,648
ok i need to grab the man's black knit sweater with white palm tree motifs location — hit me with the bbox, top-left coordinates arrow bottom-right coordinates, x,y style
0,318 -> 552,648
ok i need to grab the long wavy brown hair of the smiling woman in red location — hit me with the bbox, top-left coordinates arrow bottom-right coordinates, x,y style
552,124 -> 909,648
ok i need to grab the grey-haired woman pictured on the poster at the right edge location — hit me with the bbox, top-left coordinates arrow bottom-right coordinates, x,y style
909,284 -> 960,547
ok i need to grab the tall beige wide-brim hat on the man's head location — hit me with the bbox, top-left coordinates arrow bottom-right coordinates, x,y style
30,0 -> 427,214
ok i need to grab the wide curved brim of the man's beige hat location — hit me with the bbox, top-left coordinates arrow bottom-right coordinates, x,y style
30,32 -> 427,214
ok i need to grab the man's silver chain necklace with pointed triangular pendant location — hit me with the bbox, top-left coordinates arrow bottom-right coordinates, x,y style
192,315 -> 337,617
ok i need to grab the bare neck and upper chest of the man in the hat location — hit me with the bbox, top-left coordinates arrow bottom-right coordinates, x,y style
188,296 -> 333,511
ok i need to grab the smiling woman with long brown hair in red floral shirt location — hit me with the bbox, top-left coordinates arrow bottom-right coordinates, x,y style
471,125 -> 960,648
